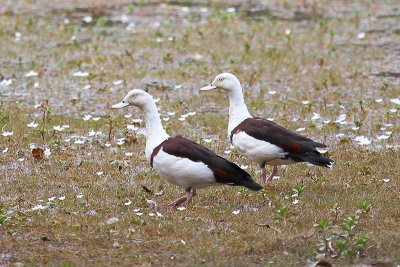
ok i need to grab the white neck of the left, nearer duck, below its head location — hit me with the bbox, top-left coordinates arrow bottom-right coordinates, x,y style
142,102 -> 169,160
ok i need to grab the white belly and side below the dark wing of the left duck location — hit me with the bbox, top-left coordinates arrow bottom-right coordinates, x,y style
153,148 -> 215,189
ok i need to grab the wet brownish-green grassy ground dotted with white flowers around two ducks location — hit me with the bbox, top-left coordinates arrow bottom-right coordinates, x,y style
0,1 -> 400,266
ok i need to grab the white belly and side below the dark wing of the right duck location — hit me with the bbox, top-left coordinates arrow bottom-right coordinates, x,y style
232,132 -> 286,165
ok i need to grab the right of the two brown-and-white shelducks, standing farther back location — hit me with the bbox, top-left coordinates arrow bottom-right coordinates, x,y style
200,73 -> 333,183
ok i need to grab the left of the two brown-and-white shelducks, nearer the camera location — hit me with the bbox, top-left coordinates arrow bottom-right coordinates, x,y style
112,89 -> 262,207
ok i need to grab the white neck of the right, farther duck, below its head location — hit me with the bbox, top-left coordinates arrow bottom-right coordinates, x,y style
228,85 -> 251,136
